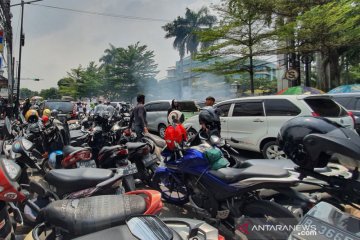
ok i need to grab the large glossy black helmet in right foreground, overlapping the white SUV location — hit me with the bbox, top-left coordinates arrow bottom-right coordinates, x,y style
278,116 -> 360,170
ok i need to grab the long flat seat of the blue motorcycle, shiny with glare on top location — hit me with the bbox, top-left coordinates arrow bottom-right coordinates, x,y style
209,165 -> 290,183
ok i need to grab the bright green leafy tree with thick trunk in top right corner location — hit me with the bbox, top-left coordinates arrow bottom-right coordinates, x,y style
280,0 -> 360,90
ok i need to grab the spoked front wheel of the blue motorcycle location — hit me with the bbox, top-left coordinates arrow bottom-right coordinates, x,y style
151,172 -> 189,205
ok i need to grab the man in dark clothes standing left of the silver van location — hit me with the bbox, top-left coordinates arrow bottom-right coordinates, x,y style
129,94 -> 149,141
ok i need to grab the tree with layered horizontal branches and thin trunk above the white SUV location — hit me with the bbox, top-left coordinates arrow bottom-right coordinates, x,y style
196,0 -> 275,94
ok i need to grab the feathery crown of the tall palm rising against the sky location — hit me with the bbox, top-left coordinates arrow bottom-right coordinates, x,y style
162,7 -> 216,60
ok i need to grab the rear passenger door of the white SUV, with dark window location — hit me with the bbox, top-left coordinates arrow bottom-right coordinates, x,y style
226,100 -> 267,151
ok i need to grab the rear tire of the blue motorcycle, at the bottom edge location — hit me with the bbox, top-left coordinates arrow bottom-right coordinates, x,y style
235,200 -> 298,240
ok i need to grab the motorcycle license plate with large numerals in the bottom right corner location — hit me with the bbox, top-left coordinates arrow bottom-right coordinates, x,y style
289,216 -> 360,240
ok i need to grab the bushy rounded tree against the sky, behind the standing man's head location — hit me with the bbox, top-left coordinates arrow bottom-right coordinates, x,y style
100,42 -> 158,100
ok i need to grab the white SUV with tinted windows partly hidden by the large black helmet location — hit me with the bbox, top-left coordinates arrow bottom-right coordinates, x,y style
184,95 -> 354,159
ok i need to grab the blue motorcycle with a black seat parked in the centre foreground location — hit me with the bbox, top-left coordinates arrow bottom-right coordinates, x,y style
152,133 -> 297,239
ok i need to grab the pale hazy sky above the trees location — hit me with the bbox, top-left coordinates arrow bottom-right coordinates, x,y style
11,0 -> 219,90
